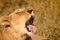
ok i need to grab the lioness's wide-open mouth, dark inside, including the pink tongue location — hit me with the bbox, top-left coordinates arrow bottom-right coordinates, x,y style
25,16 -> 36,33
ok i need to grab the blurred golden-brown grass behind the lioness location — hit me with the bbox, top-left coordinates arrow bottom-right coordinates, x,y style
0,0 -> 60,40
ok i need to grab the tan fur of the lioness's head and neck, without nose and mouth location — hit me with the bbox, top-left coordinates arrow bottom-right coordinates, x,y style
0,8 -> 43,40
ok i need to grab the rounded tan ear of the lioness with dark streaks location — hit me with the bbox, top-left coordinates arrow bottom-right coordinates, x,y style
0,16 -> 11,28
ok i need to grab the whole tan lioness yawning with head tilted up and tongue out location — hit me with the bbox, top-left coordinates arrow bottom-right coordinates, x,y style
0,8 -> 36,40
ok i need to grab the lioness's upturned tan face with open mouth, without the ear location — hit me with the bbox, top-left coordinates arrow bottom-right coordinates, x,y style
10,8 -> 36,35
